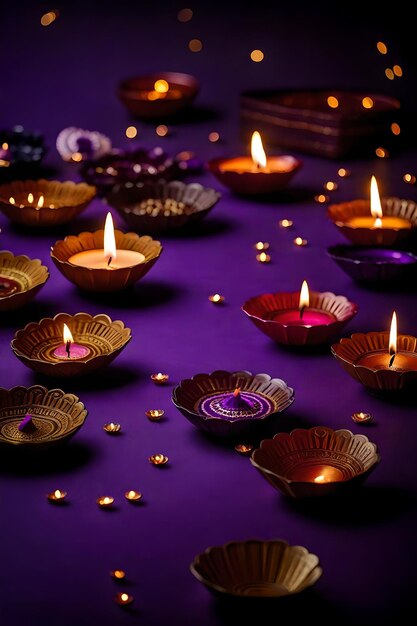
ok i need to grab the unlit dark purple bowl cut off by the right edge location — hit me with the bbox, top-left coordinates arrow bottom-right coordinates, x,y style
327,245 -> 417,286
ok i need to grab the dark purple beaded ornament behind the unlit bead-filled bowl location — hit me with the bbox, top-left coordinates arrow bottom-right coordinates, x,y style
80,147 -> 200,196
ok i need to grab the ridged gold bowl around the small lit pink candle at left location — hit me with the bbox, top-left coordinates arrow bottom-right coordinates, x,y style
10,313 -> 132,377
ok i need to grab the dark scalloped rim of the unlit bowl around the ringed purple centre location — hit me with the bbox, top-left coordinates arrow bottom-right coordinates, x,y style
172,370 -> 294,438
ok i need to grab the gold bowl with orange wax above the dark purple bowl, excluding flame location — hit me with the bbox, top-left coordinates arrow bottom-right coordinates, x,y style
327,198 -> 417,247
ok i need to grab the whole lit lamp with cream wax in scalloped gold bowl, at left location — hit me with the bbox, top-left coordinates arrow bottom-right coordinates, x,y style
51,213 -> 162,291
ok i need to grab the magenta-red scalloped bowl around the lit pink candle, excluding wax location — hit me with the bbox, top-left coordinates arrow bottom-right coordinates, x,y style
241,291 -> 358,346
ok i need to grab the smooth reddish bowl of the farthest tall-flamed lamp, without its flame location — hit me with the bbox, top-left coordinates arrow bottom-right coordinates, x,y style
207,154 -> 302,196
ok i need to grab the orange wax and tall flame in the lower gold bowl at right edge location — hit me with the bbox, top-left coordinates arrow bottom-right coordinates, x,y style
356,311 -> 417,372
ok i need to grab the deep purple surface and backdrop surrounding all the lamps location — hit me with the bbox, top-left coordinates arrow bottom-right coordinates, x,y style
0,1 -> 417,626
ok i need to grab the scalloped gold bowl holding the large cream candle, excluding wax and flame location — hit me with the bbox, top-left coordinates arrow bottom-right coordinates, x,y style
51,229 -> 162,292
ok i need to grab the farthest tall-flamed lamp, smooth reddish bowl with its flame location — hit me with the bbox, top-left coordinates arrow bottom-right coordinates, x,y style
207,131 -> 302,195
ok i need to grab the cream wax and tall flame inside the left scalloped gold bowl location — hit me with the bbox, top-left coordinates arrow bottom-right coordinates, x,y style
68,213 -> 146,270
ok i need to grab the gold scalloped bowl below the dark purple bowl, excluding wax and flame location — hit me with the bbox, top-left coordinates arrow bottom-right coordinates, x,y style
331,332 -> 417,393
